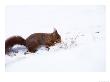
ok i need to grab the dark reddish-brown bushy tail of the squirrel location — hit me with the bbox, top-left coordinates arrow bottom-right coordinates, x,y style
5,36 -> 26,54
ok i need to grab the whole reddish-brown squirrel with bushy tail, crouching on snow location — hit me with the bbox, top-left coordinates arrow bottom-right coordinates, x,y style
5,29 -> 61,54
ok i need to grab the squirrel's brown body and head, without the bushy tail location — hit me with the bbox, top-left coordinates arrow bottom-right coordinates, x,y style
26,30 -> 61,52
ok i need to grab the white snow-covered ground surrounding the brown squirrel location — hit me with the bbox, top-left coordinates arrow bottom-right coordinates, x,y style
5,6 -> 106,72
